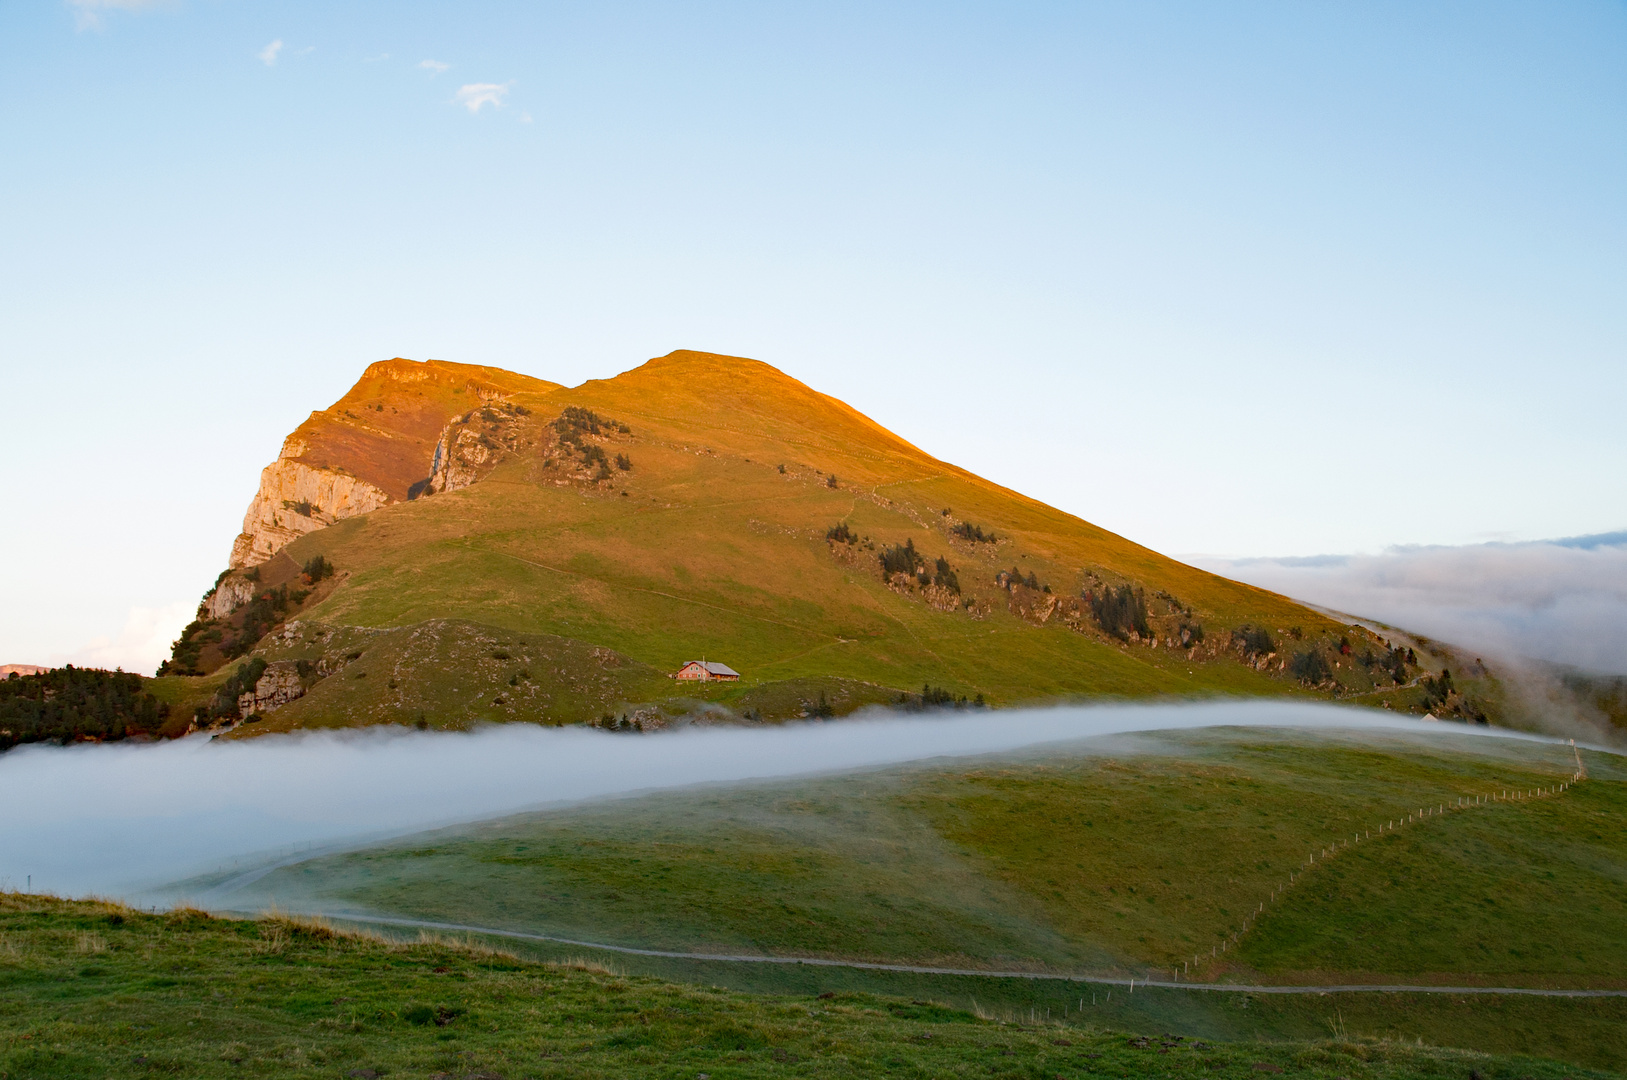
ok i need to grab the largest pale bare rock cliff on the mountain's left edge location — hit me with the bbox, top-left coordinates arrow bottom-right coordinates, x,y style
227,436 -> 395,569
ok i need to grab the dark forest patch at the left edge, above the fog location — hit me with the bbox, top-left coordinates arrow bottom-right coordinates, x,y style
0,665 -> 169,751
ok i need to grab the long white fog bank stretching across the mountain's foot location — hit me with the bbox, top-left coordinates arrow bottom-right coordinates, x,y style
0,703 -> 1561,898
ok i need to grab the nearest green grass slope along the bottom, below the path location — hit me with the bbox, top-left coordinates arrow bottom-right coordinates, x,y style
0,893 -> 1612,1080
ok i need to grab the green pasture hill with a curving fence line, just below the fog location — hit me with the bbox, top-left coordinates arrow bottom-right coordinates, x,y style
212,729 -> 1627,1067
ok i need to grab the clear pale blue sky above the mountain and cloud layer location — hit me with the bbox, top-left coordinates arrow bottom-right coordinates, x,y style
0,0 -> 1627,668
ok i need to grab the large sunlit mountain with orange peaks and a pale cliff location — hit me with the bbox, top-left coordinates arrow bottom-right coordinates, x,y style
158,351 -> 1495,734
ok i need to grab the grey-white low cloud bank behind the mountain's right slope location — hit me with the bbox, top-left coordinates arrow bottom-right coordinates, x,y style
1188,532 -> 1627,675
